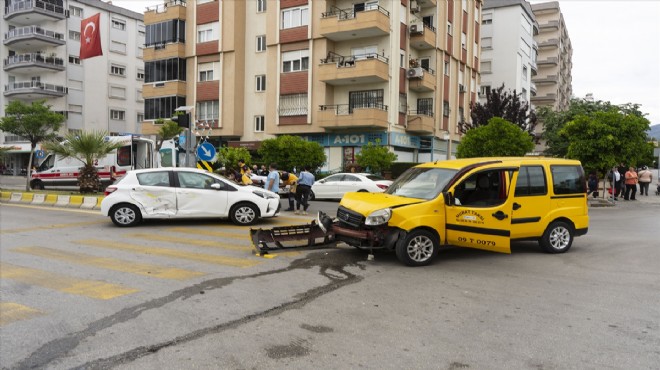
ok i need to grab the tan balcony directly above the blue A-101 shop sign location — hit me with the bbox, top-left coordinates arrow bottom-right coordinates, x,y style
317,103 -> 389,131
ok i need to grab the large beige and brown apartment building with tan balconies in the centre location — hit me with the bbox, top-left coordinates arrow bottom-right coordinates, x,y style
142,0 -> 482,170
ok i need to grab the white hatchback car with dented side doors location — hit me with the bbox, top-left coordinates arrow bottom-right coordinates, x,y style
101,168 -> 280,226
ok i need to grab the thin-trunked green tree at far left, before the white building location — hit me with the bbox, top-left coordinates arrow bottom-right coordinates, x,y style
0,100 -> 65,191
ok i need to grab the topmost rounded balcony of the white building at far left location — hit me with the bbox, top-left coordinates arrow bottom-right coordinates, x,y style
4,0 -> 68,26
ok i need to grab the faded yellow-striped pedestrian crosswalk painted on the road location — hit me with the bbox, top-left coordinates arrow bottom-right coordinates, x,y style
0,217 -> 316,327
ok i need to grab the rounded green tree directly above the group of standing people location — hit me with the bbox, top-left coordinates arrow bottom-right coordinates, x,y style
258,135 -> 326,171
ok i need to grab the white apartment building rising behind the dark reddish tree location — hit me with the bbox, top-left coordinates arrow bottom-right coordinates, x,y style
479,0 -> 539,103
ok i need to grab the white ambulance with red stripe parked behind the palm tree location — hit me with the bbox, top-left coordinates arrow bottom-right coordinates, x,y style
30,135 -> 157,189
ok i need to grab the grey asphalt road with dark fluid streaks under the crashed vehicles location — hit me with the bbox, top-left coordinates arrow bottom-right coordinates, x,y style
0,201 -> 660,369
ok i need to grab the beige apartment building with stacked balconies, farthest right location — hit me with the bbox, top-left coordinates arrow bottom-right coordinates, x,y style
532,1 -> 573,111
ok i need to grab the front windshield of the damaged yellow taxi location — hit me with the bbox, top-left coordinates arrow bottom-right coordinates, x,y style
385,167 -> 458,200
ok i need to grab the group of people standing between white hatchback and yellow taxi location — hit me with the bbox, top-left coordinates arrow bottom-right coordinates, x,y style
235,160 -> 315,215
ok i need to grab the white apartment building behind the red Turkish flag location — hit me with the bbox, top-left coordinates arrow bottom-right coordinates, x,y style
0,0 -> 145,174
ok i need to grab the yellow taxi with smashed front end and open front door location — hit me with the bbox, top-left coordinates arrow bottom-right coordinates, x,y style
333,157 -> 589,266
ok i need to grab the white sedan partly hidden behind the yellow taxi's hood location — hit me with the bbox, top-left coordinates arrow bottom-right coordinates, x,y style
311,173 -> 392,199
